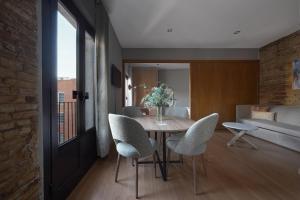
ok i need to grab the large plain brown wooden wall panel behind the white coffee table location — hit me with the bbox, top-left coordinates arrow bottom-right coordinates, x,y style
190,61 -> 259,128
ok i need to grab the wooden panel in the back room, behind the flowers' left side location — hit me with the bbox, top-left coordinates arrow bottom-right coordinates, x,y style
132,67 -> 158,106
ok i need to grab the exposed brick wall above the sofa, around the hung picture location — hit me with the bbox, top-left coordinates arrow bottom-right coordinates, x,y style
260,31 -> 300,105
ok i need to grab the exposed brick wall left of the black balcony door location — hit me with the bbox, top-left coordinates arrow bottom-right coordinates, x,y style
0,0 -> 40,199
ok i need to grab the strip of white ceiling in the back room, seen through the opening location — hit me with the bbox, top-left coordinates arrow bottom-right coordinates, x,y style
129,63 -> 190,70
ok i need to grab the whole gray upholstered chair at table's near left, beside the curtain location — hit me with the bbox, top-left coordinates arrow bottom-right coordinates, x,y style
108,114 -> 161,198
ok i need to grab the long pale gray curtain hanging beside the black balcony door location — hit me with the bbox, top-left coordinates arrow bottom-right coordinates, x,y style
96,1 -> 112,157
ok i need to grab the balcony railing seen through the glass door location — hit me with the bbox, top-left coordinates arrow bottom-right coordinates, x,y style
57,102 -> 77,144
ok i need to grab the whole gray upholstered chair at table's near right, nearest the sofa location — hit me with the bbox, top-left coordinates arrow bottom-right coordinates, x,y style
166,113 -> 219,193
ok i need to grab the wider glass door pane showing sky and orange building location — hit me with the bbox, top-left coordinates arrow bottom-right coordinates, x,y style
57,5 -> 78,145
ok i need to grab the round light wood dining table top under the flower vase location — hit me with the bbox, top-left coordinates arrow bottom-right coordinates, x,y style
134,116 -> 195,133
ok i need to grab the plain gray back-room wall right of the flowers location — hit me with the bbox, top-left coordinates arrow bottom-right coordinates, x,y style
158,69 -> 190,107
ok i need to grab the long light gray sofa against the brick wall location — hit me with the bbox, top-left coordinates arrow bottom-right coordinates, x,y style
236,105 -> 300,152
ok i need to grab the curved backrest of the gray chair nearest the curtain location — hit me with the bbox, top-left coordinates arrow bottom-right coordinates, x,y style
108,114 -> 153,157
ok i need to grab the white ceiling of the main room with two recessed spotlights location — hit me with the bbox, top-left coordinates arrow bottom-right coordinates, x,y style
103,0 -> 300,48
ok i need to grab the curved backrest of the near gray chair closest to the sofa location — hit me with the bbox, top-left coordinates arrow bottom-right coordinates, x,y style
175,113 -> 219,155
